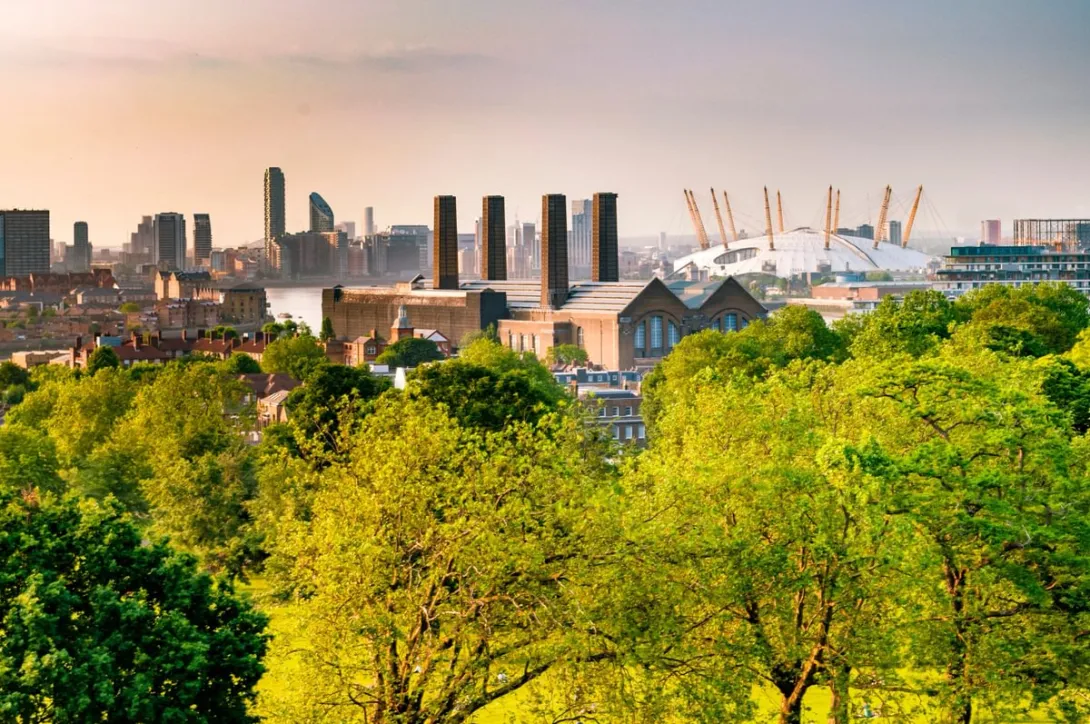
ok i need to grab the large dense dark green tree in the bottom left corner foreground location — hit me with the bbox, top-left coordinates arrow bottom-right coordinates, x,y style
0,493 -> 267,723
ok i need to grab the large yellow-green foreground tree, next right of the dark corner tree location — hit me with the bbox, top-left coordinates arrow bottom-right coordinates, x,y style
258,398 -> 610,722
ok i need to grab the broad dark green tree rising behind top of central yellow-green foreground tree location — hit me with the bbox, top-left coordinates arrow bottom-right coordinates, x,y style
405,360 -> 558,432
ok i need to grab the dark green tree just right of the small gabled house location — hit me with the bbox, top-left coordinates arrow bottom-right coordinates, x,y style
287,364 -> 390,449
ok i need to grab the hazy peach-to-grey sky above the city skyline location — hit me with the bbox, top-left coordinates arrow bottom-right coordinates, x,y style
0,0 -> 1090,246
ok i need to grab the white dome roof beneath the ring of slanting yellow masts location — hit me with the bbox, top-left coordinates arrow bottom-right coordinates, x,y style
674,227 -> 932,278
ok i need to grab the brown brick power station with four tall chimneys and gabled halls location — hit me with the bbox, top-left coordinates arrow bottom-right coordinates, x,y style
322,194 -> 765,370
